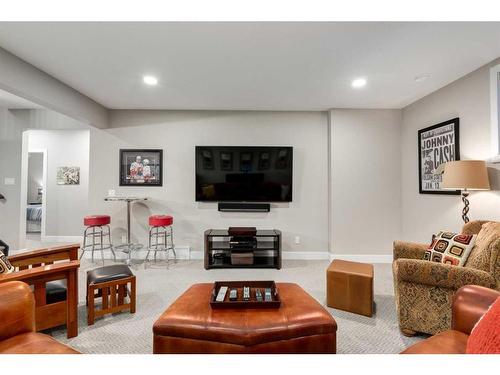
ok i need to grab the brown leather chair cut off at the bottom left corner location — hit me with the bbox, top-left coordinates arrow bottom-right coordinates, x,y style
0,281 -> 78,354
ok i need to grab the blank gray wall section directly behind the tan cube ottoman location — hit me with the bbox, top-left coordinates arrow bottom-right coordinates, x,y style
330,109 -> 401,260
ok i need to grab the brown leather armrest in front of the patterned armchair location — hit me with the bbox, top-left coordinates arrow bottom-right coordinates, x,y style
451,285 -> 500,335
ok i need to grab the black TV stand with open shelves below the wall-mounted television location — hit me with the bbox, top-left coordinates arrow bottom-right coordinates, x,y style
205,229 -> 281,270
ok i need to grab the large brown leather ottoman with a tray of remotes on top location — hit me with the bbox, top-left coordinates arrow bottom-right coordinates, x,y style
153,283 -> 337,354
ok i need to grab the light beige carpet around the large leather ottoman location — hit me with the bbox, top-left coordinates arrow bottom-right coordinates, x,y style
44,261 -> 421,354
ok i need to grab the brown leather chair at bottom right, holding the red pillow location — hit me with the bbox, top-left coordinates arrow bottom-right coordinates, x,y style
401,285 -> 500,354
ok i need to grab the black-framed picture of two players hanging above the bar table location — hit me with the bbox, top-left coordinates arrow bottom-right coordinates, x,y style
119,148 -> 163,187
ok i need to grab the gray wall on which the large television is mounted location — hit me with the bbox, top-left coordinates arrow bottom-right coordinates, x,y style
89,111 -> 328,255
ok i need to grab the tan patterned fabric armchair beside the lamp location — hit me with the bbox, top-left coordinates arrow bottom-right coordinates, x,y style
392,221 -> 500,336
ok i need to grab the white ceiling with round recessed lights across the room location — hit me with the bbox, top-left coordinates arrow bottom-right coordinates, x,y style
0,22 -> 500,110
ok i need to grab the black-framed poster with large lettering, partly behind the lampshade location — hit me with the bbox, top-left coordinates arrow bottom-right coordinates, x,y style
418,117 -> 460,195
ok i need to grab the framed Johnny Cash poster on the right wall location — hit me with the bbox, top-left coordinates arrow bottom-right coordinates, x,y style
418,117 -> 460,195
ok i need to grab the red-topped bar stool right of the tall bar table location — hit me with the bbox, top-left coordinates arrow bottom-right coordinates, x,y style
146,215 -> 177,261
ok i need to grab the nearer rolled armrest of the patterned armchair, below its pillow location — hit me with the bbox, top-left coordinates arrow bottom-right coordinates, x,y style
393,259 -> 496,289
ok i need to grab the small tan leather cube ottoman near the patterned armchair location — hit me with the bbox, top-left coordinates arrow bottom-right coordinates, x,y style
326,259 -> 373,316
